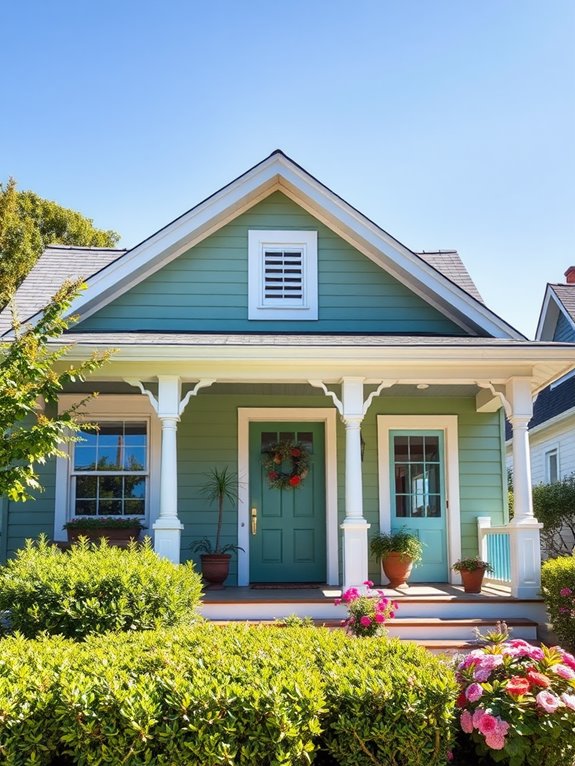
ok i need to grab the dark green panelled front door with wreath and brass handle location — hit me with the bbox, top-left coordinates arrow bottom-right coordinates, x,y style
250,423 -> 326,583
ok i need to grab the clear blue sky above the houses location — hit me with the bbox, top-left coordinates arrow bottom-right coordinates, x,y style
0,0 -> 575,336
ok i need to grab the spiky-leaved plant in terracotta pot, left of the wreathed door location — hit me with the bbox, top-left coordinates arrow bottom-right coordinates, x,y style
190,466 -> 243,589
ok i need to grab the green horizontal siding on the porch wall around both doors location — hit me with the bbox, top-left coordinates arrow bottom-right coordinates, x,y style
0,385 -> 506,585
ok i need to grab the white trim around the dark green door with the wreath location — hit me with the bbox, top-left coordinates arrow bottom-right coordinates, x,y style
238,407 -> 339,586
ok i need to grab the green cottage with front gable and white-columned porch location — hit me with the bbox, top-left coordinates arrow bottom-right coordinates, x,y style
0,151 -> 575,596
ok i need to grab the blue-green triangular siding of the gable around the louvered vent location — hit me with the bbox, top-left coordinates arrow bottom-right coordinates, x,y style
75,192 -> 464,335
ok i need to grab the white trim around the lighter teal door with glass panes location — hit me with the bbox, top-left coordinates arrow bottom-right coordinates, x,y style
377,415 -> 461,583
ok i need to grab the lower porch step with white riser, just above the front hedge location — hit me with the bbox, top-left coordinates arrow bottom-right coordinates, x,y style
205,615 -> 537,640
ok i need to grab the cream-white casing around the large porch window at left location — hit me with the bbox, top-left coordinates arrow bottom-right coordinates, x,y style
53,394 -> 161,540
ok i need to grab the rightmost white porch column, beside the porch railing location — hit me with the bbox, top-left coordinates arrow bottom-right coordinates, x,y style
505,377 -> 543,598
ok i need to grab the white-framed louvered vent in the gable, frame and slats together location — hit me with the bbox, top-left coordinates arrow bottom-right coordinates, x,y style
248,230 -> 318,320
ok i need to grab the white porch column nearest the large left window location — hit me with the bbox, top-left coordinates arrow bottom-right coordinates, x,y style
153,375 -> 184,564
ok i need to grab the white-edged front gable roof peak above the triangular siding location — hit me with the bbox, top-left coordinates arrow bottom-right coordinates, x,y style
0,150 -> 524,338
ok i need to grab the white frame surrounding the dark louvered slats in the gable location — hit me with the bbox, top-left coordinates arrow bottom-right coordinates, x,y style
248,229 -> 318,321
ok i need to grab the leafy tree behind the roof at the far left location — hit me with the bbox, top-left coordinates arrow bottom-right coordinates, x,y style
0,178 -> 120,308
